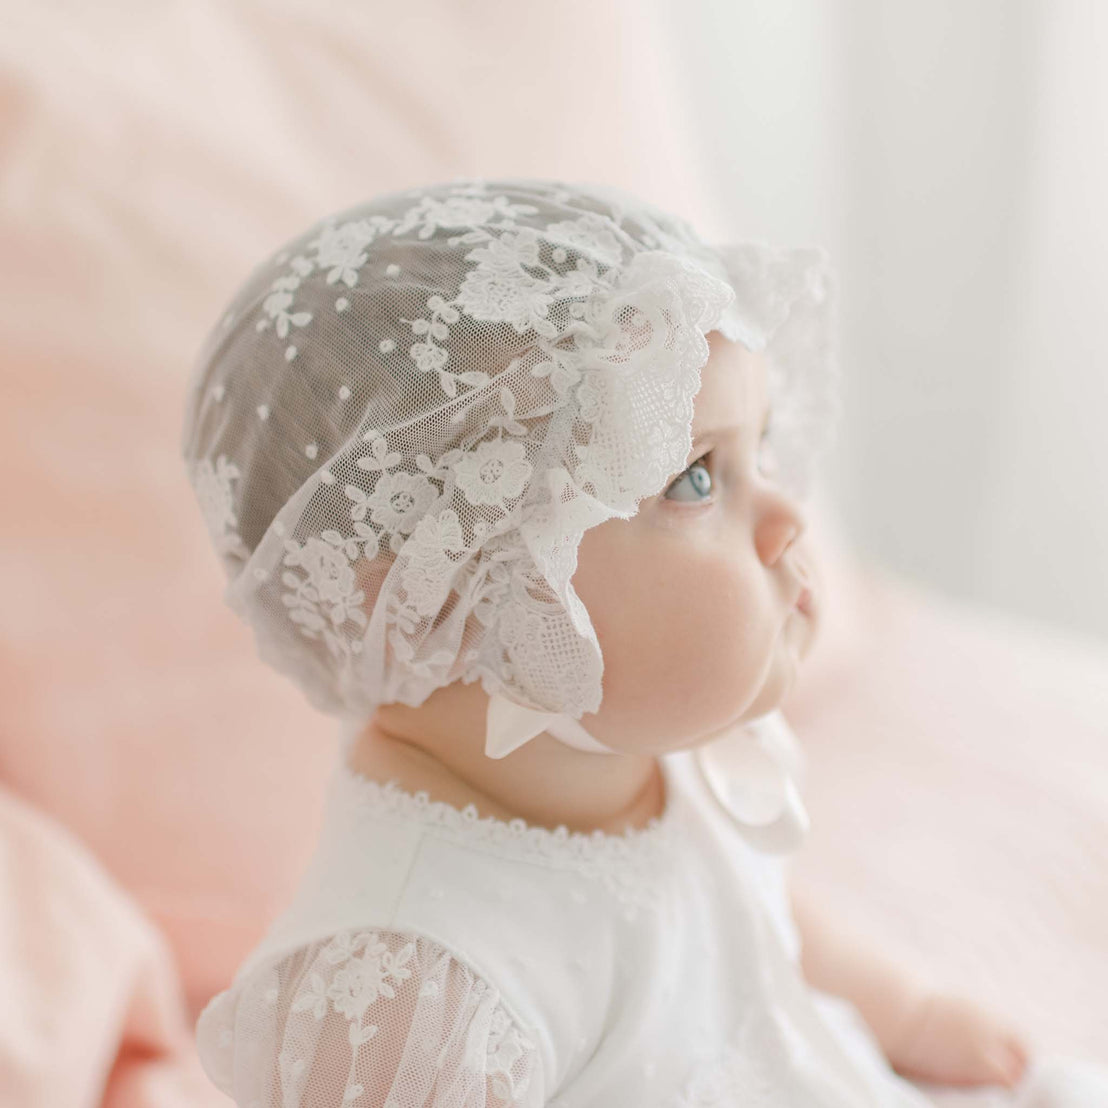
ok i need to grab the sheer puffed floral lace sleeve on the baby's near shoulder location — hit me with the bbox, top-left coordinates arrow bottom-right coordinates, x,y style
196,930 -> 543,1108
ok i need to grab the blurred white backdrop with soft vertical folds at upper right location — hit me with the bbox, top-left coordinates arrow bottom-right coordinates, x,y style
656,0 -> 1108,640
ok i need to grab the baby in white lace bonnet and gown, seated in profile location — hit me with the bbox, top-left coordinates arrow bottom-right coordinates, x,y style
183,181 -> 1045,1108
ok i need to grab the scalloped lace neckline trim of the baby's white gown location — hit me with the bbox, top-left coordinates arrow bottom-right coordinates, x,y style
335,751 -> 681,862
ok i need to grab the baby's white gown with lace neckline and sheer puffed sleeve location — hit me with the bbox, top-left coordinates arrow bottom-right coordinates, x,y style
197,711 -> 1108,1108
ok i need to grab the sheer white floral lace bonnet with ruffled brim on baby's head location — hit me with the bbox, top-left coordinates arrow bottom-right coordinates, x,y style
182,179 -> 838,757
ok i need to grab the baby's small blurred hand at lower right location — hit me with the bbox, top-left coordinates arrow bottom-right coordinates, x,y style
888,992 -> 1029,1088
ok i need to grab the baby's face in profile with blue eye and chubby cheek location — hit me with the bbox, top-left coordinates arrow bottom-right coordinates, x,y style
573,331 -> 815,752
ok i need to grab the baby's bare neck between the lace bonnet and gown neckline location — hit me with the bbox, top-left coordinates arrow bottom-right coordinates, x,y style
347,686 -> 667,834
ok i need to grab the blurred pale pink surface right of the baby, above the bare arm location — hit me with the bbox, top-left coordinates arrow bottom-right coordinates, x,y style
784,549 -> 1108,1060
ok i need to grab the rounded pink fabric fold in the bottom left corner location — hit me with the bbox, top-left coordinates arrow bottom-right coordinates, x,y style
0,788 -> 227,1108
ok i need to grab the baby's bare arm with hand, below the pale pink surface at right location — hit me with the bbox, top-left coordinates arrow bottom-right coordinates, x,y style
789,884 -> 1028,1087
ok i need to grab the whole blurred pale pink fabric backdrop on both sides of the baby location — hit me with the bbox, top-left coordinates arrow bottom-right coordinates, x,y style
0,0 -> 1108,1108
